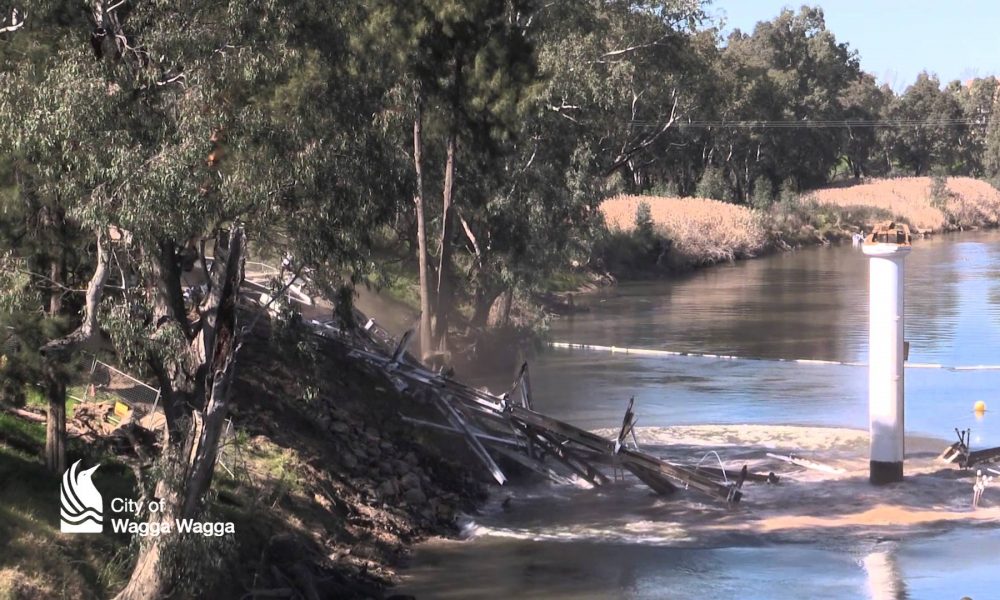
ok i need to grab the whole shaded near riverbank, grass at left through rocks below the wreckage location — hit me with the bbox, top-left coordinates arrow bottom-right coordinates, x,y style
0,320 -> 486,600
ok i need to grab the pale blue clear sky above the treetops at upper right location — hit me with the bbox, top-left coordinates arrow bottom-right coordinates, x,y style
708,0 -> 1000,92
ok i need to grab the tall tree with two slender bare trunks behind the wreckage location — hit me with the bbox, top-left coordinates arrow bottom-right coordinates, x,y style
360,0 -> 536,355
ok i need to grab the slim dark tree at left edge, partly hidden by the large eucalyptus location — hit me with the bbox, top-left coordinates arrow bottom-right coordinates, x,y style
0,0 -> 102,472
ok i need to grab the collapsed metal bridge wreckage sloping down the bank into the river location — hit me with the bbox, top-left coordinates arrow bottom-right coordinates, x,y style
307,319 -> 752,504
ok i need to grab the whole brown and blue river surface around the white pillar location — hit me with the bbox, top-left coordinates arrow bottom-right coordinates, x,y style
400,232 -> 1000,599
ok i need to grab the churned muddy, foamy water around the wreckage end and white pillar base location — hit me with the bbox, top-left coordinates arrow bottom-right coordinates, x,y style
456,425 -> 1000,545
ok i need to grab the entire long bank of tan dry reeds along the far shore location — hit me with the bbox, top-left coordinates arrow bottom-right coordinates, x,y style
600,177 -> 1000,277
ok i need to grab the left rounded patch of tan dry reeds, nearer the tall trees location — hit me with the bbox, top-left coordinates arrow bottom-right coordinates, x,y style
601,196 -> 767,266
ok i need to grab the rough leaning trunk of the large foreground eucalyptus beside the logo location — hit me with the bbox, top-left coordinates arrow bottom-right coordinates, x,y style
116,228 -> 246,600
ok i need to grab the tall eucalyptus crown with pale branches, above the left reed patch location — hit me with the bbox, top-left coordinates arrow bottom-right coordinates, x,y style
535,0 -> 706,189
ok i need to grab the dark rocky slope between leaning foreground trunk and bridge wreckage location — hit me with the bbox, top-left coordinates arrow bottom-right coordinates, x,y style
213,316 -> 486,598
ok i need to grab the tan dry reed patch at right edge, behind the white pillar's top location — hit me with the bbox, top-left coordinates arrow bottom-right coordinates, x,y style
809,177 -> 1000,231
